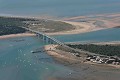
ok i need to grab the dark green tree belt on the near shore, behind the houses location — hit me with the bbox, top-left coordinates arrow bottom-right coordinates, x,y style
68,44 -> 120,57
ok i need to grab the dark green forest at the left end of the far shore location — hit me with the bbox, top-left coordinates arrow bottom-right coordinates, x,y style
0,17 -> 35,36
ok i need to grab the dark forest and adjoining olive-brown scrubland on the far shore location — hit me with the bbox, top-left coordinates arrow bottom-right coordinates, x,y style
0,17 -> 74,35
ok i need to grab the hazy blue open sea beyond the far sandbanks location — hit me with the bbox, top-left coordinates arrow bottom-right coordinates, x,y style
0,0 -> 120,17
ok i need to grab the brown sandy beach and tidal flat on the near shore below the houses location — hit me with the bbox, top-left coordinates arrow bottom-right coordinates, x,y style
44,45 -> 120,80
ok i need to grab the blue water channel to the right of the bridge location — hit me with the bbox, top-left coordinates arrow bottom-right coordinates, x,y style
53,28 -> 120,42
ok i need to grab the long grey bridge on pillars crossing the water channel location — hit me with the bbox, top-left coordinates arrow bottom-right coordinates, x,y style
23,27 -> 95,55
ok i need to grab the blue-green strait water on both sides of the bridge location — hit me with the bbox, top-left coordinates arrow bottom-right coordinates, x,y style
0,28 -> 120,80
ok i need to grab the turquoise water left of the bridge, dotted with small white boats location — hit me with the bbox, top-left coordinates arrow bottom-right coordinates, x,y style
0,37 -> 71,80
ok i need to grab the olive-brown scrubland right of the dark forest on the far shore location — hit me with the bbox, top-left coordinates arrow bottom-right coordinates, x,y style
28,19 -> 74,33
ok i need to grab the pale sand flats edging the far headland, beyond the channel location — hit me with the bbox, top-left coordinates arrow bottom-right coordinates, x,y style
0,13 -> 120,35
